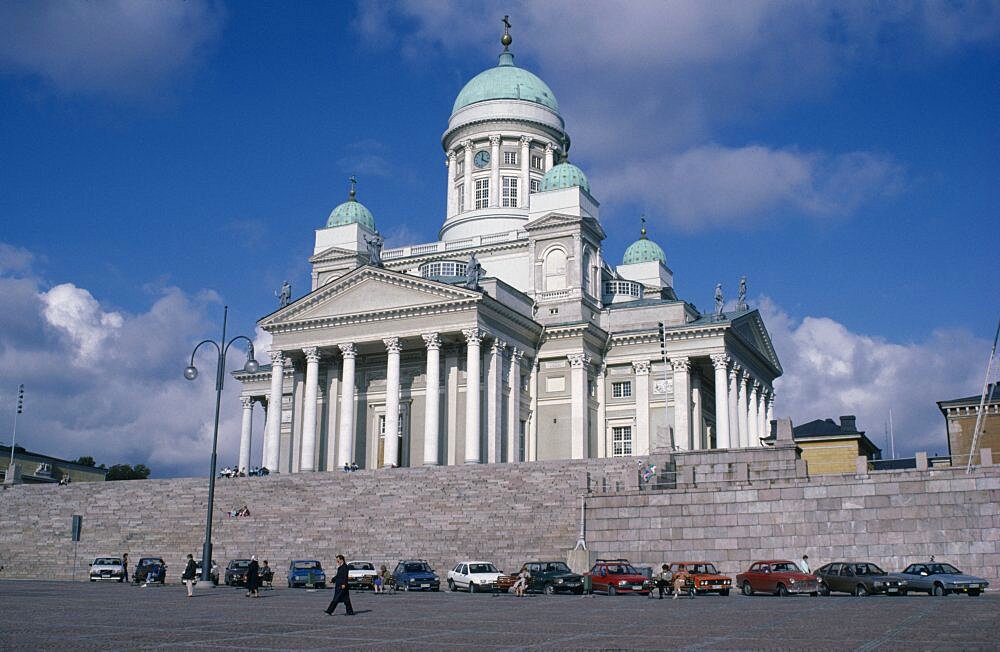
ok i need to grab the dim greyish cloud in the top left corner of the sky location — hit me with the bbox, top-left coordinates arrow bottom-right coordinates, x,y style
0,0 -> 223,98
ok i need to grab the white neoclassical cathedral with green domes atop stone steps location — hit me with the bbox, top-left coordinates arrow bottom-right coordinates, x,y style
234,28 -> 781,473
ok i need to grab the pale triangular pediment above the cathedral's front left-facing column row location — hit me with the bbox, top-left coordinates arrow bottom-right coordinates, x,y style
260,265 -> 482,329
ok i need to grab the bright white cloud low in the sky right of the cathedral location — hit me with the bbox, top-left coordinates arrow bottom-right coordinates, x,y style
760,297 -> 990,457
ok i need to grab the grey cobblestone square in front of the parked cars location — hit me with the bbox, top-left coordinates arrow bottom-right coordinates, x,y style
0,580 -> 1000,650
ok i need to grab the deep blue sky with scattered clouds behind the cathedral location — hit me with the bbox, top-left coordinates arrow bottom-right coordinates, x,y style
0,0 -> 1000,476
